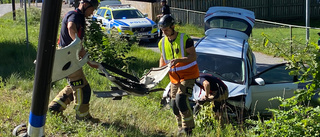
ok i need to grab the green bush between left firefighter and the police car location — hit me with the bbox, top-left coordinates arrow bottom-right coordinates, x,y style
84,21 -> 136,71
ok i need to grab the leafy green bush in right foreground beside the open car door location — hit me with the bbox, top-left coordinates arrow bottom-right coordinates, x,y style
247,35 -> 320,136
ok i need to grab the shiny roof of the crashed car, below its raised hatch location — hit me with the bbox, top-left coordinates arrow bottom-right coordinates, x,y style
196,35 -> 245,58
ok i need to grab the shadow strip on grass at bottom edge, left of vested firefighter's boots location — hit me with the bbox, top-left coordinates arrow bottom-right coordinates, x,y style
101,121 -> 166,137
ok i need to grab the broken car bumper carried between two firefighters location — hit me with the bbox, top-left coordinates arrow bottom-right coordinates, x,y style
52,35 -> 170,99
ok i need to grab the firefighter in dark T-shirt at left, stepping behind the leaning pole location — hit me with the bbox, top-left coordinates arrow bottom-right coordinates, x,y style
49,0 -> 99,122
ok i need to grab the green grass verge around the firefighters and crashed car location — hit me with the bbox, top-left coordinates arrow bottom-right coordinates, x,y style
0,9 -> 316,137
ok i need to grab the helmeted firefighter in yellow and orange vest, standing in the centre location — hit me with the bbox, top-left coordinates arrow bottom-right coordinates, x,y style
158,15 -> 199,135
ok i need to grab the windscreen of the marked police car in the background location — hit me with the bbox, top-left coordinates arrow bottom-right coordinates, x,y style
112,10 -> 144,19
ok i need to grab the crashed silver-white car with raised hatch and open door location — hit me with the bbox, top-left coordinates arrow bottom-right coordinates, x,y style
163,7 -> 305,118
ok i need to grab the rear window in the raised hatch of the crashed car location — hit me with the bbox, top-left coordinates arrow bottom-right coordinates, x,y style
205,16 -> 252,36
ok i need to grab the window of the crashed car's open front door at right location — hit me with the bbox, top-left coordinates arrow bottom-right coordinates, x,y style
259,65 -> 295,84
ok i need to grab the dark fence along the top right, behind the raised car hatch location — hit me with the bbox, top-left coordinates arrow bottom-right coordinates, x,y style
169,0 -> 320,21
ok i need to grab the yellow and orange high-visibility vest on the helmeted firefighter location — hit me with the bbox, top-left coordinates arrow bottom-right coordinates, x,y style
159,33 -> 199,84
